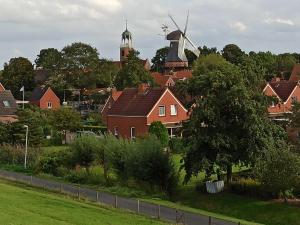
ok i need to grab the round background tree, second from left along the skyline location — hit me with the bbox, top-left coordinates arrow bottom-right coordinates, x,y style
34,48 -> 62,73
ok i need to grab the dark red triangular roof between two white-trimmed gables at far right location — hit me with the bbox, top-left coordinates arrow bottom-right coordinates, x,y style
269,80 -> 298,102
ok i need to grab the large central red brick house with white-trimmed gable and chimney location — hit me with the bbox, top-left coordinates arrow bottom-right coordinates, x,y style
107,84 -> 188,138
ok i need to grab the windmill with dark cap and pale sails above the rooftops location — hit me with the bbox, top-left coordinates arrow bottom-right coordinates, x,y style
166,13 -> 200,68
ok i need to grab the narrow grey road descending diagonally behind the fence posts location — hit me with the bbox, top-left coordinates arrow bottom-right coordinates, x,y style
0,170 -> 241,225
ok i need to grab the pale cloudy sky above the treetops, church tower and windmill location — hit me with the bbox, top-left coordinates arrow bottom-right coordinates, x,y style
0,0 -> 300,69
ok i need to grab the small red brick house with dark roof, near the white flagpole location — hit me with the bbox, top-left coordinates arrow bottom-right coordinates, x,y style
29,87 -> 60,109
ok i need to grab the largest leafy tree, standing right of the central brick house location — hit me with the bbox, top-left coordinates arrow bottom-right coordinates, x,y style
184,55 -> 285,182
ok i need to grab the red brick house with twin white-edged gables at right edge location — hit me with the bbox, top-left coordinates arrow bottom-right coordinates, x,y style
263,79 -> 300,118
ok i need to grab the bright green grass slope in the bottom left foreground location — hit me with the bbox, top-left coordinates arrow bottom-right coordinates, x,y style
0,180 -> 165,225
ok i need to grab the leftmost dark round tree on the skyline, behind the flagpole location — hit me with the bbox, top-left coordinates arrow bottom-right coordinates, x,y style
1,57 -> 35,98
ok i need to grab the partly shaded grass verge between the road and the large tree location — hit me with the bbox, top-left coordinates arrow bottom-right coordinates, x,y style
37,147 -> 300,225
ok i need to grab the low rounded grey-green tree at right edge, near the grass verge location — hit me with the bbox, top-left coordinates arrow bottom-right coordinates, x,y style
254,143 -> 300,200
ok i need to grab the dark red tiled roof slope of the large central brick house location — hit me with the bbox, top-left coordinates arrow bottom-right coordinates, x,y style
108,87 -> 166,116
